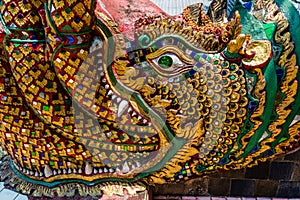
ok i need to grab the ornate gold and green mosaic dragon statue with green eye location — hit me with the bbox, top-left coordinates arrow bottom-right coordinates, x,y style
0,0 -> 300,197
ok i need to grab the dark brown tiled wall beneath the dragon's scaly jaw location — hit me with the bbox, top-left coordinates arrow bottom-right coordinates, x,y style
153,151 -> 300,200
